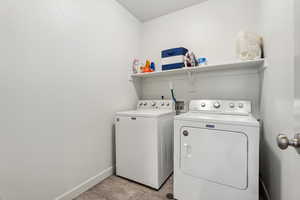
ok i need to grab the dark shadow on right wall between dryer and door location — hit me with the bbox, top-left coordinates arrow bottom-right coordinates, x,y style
260,123 -> 282,200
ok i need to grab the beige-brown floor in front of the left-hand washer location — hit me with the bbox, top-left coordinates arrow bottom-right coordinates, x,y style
74,176 -> 173,200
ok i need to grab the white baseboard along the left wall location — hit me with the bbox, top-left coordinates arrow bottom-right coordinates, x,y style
54,167 -> 113,200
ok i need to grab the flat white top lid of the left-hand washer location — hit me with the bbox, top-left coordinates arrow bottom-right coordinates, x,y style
116,110 -> 175,117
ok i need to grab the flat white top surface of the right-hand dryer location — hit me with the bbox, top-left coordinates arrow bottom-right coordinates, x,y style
175,112 -> 259,126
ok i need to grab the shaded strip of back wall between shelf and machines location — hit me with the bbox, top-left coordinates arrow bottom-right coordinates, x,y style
139,69 -> 261,114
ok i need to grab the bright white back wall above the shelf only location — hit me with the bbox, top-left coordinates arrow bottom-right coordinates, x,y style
141,0 -> 258,68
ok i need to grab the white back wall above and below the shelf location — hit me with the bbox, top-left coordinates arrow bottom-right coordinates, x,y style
141,0 -> 260,115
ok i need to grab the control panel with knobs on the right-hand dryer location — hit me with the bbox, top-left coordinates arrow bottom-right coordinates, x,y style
189,100 -> 251,115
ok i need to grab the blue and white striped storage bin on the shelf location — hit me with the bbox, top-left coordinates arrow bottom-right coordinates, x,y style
161,47 -> 188,71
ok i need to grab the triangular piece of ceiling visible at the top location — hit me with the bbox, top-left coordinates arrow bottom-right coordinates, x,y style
117,0 -> 207,22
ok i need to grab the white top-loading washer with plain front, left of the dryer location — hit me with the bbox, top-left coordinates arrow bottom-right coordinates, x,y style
115,100 -> 175,189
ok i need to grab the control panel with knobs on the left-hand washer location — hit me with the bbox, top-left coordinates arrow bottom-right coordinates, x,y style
137,100 -> 175,110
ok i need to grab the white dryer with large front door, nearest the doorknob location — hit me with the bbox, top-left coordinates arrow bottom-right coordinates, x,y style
174,100 -> 259,200
